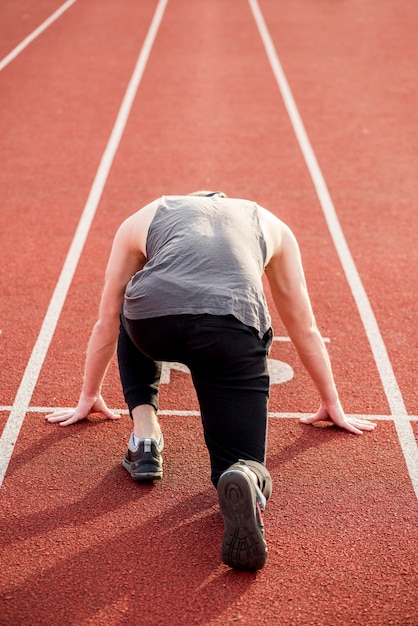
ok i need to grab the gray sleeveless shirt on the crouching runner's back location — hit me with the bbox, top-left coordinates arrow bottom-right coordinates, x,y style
124,196 -> 271,336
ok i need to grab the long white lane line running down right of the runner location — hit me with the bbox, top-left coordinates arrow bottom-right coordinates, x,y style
248,0 -> 418,498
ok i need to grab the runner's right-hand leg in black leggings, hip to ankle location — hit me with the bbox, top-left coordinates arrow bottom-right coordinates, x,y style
184,318 -> 269,484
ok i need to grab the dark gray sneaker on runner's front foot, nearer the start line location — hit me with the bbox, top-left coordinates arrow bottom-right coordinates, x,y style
122,435 -> 164,482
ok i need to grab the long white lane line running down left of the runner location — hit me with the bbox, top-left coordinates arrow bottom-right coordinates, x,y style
0,0 -> 168,486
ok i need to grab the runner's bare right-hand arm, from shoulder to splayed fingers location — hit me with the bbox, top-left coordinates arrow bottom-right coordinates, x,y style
266,214 -> 375,434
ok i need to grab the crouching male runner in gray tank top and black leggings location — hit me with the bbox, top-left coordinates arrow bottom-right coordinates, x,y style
47,192 -> 375,570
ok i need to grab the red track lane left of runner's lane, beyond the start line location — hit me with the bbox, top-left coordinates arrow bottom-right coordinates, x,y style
0,2 -> 160,405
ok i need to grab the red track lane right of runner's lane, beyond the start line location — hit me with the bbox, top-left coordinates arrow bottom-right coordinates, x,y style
260,0 -> 418,414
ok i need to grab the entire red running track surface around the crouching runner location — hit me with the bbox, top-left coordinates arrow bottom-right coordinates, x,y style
0,0 -> 418,626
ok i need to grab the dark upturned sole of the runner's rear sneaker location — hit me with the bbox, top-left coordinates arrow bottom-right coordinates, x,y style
218,470 -> 267,570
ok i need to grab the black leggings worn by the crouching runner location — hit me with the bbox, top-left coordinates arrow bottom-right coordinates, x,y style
118,314 -> 271,486
